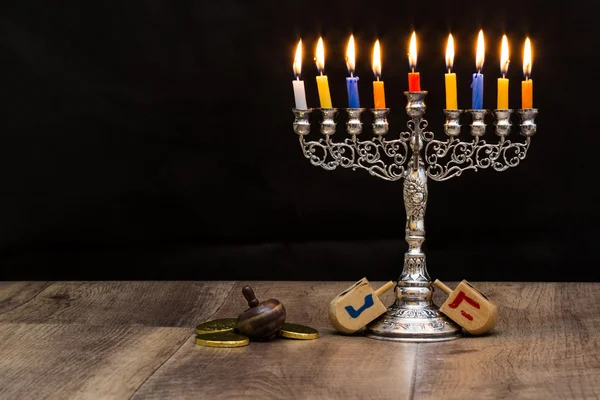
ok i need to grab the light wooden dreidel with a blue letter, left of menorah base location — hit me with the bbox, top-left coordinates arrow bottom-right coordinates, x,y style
329,278 -> 394,333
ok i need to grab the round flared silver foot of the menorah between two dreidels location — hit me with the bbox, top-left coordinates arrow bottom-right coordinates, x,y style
366,304 -> 462,342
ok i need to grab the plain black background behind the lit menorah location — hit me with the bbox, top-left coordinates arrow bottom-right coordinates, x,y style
0,0 -> 600,281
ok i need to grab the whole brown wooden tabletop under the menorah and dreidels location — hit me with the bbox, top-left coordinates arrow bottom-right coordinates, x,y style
0,282 -> 600,399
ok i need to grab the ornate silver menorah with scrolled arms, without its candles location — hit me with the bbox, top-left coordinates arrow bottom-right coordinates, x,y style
293,91 -> 538,341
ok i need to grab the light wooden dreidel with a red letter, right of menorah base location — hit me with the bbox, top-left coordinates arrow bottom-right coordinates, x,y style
433,279 -> 498,335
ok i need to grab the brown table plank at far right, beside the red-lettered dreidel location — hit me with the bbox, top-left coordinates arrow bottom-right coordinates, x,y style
415,283 -> 600,399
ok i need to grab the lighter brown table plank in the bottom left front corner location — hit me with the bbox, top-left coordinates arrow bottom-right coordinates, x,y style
0,323 -> 190,399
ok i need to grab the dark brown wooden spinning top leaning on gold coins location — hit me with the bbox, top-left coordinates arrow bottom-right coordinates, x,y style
235,286 -> 286,340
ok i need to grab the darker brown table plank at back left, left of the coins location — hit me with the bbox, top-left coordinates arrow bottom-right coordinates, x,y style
0,282 -> 234,327
